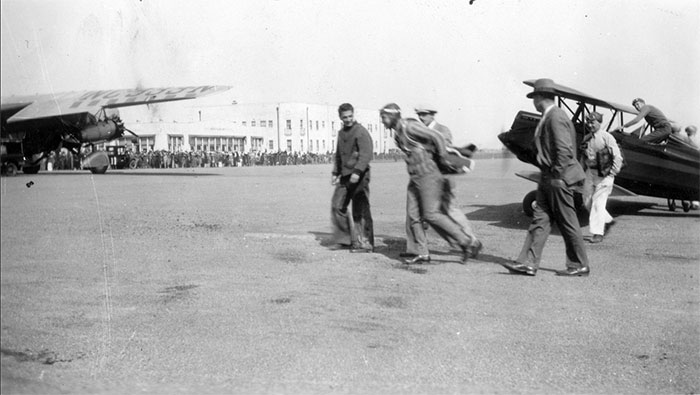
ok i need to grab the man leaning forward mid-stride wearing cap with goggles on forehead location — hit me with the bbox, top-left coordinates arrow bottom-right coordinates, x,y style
379,103 -> 480,264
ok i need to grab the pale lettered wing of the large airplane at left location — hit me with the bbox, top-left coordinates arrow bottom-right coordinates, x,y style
2,86 -> 230,123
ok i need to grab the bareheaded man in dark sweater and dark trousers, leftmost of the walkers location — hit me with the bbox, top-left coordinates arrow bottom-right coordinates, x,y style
331,103 -> 374,252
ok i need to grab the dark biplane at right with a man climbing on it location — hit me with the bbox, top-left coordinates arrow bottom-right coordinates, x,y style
498,80 -> 700,216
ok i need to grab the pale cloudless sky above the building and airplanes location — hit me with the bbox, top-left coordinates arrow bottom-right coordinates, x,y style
0,0 -> 700,148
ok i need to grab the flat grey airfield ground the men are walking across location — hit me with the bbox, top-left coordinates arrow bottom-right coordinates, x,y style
0,159 -> 700,394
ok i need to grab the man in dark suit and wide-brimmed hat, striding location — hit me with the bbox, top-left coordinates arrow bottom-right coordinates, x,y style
503,79 -> 590,276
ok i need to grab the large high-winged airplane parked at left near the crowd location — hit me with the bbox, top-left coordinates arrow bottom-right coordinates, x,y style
0,86 -> 229,174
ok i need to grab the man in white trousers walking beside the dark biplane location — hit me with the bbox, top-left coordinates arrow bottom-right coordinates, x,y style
584,112 -> 622,243
